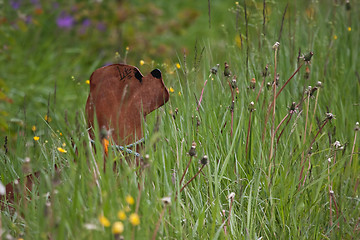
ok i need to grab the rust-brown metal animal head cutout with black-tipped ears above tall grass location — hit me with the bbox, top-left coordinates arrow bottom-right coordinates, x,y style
86,64 -> 169,144
